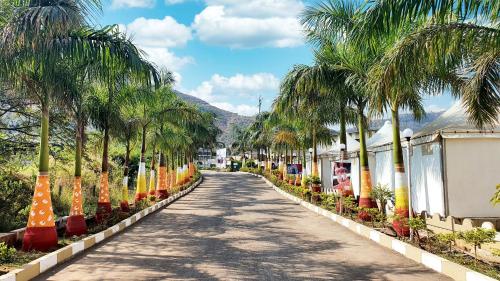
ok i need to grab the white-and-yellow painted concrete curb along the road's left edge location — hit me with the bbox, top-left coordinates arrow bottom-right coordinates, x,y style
0,177 -> 203,281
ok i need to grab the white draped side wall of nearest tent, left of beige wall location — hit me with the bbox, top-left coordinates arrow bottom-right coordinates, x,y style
411,142 -> 445,216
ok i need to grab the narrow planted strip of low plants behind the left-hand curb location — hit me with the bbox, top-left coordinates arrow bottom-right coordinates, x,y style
0,172 -> 201,275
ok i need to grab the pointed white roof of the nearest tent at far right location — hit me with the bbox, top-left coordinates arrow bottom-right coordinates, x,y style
413,101 -> 500,143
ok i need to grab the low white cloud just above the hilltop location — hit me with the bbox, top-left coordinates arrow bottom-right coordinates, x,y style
187,73 -> 279,115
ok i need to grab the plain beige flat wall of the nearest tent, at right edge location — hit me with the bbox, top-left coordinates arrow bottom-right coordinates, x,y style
444,138 -> 500,218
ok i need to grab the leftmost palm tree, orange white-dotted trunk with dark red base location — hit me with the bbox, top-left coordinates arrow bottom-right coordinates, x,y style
0,0 -> 156,250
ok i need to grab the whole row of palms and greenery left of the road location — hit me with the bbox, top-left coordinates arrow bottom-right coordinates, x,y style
0,0 -> 219,250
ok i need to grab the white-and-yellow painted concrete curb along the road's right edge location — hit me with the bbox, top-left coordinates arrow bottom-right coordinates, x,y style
240,172 -> 495,281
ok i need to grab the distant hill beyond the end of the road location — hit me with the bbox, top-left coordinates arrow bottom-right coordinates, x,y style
176,91 -> 254,147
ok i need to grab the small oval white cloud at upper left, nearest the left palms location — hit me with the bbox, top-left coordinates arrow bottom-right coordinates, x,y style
121,16 -> 192,48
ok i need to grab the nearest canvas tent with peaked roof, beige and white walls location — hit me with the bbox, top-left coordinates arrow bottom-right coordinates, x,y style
411,102 -> 500,218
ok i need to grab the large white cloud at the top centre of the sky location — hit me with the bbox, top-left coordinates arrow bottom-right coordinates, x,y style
192,0 -> 304,48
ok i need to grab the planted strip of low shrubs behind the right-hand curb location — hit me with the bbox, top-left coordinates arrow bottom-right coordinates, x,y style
246,169 -> 500,280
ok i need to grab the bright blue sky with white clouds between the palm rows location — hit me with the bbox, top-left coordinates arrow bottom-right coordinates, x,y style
98,0 -> 452,115
